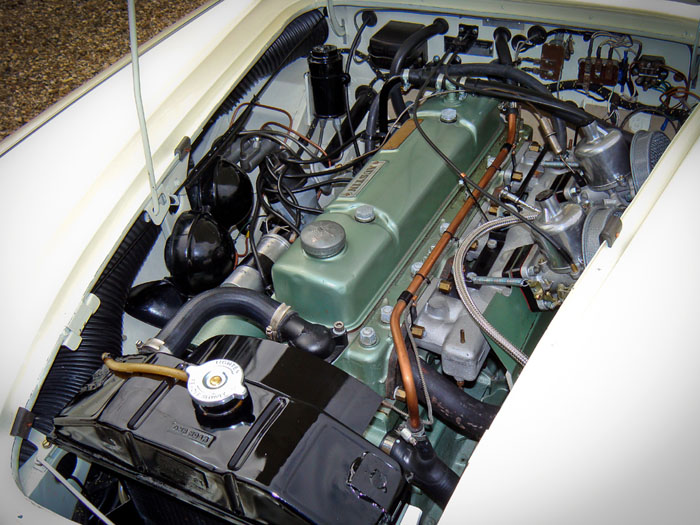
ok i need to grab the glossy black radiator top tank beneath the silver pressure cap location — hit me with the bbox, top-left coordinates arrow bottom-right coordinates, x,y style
52,336 -> 405,524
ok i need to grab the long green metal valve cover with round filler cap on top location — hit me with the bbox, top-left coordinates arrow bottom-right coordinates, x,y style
272,97 -> 503,329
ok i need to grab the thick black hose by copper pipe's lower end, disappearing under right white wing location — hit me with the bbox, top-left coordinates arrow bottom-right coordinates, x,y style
409,352 -> 500,441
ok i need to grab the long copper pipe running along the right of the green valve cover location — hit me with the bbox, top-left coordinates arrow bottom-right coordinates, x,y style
389,113 -> 517,431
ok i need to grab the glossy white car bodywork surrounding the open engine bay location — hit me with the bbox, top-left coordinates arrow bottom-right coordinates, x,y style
0,0 -> 700,524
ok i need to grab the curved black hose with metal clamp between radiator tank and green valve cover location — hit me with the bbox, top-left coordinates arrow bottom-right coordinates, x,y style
155,287 -> 336,359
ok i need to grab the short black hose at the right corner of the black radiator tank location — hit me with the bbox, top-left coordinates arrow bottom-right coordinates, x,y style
389,438 -> 459,509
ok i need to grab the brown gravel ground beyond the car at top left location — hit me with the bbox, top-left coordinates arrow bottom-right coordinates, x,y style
0,0 -> 208,140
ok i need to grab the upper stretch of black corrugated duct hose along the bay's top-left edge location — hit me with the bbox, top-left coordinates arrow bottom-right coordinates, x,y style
200,9 -> 328,136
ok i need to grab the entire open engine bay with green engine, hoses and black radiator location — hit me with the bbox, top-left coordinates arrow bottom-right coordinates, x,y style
13,6 -> 698,525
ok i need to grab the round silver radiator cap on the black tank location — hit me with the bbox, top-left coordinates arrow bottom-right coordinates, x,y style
187,359 -> 248,408
